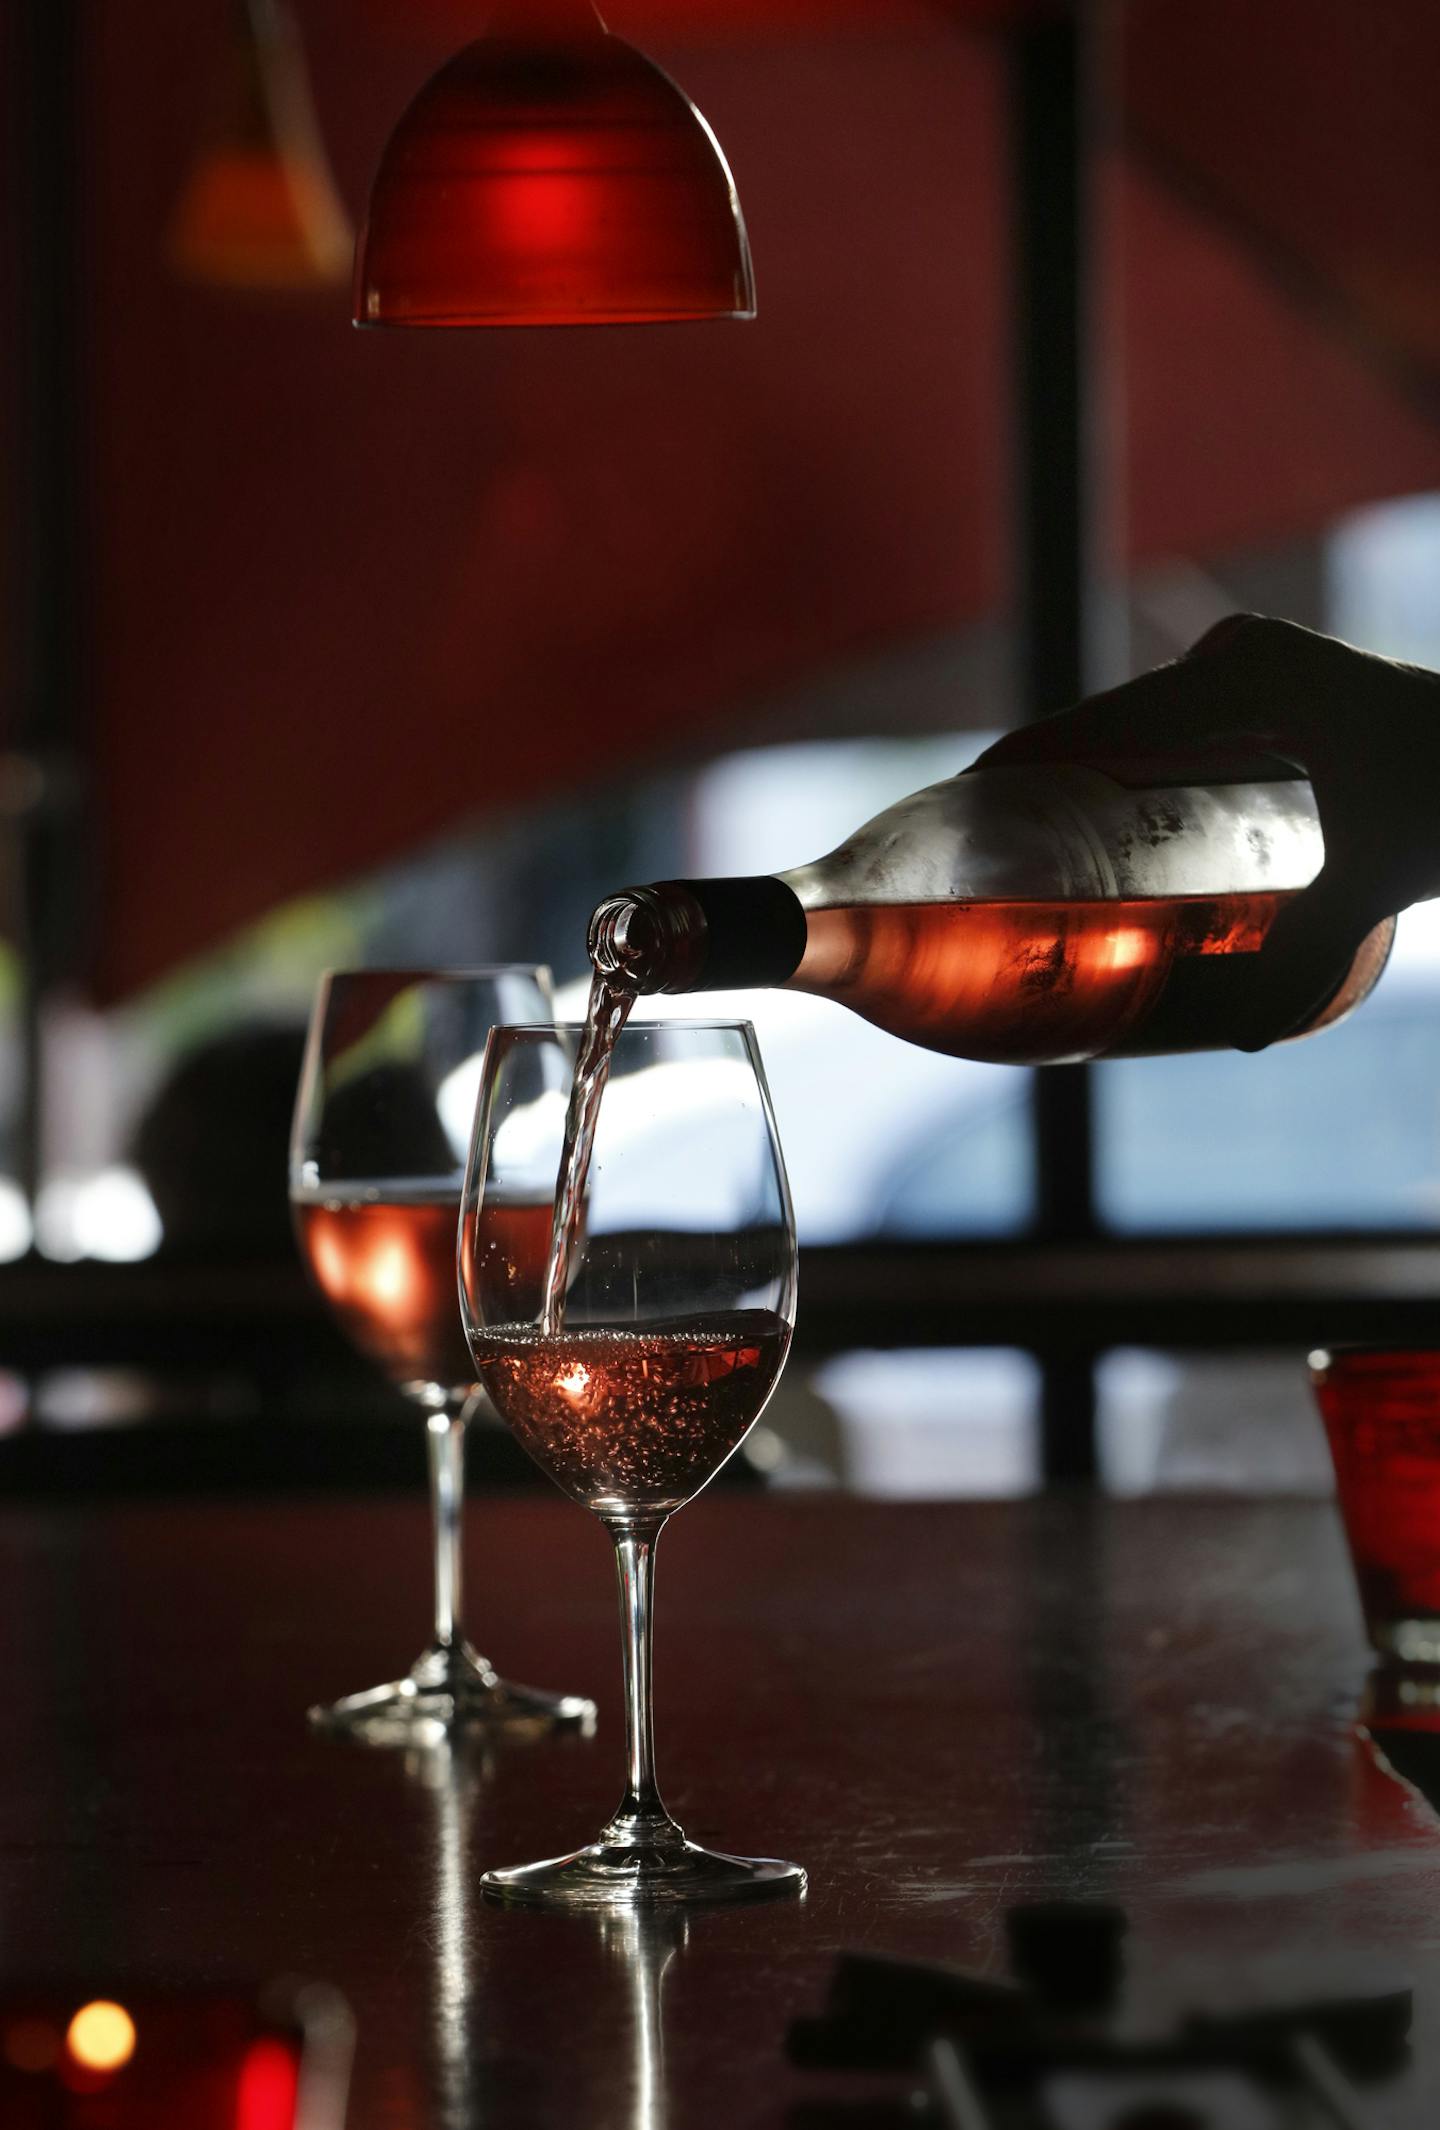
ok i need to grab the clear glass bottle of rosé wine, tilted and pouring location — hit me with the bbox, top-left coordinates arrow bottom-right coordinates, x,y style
590,763 -> 1395,1065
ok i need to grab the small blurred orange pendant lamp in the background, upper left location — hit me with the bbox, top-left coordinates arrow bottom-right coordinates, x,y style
168,0 -> 354,290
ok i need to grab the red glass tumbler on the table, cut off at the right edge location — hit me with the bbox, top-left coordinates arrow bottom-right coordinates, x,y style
1310,1346 -> 1440,1666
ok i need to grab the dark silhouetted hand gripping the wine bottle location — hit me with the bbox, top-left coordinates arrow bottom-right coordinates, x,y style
980,613 -> 1440,1050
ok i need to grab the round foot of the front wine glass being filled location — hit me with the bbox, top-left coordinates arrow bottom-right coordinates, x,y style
479,1836 -> 805,1908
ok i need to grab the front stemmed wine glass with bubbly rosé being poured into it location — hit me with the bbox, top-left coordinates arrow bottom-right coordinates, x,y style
460,1020 -> 805,1908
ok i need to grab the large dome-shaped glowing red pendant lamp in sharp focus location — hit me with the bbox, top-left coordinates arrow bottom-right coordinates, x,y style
354,0 -> 754,326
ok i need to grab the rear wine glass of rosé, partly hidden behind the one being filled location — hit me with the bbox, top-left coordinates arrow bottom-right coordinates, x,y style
290,967 -> 594,1744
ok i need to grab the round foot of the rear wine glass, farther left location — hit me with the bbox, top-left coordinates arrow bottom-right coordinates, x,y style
309,1642 -> 594,1744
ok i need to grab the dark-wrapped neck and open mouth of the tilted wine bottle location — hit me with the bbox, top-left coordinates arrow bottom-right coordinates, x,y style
590,878 -> 805,993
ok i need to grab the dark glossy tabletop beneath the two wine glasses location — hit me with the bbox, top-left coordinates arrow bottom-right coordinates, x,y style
0,1495 -> 1440,2130
